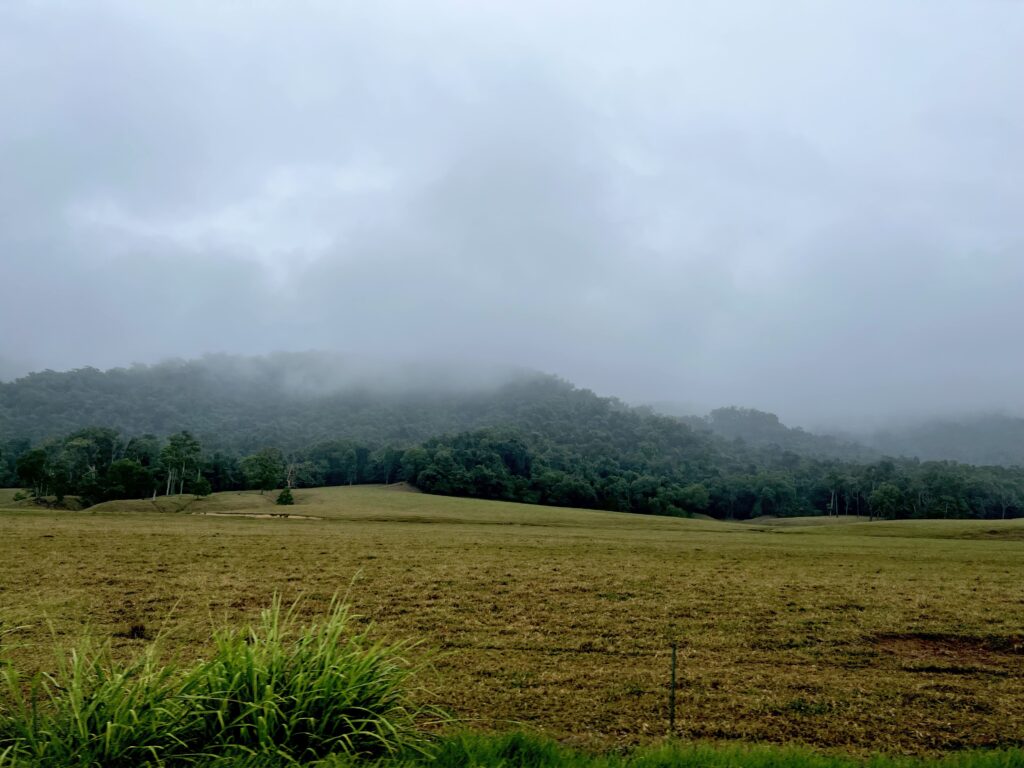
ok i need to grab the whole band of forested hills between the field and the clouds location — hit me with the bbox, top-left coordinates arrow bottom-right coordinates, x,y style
0,355 -> 1024,519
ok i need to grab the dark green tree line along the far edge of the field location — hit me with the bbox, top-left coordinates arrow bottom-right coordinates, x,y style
0,421 -> 1024,520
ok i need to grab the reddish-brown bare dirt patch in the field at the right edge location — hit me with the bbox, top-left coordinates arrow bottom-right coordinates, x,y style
872,632 -> 1024,674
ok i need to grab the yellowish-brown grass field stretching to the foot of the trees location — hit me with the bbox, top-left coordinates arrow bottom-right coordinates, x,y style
0,486 -> 1024,754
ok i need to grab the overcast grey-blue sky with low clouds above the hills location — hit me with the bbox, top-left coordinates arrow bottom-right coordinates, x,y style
0,0 -> 1024,427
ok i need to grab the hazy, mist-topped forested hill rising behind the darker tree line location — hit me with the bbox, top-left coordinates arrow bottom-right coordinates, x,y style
0,354 -> 734,473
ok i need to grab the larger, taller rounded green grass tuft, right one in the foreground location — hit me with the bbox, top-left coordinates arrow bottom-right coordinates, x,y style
189,598 -> 434,761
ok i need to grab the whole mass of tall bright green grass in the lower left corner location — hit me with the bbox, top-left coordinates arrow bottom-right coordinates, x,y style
0,598 -> 431,767
